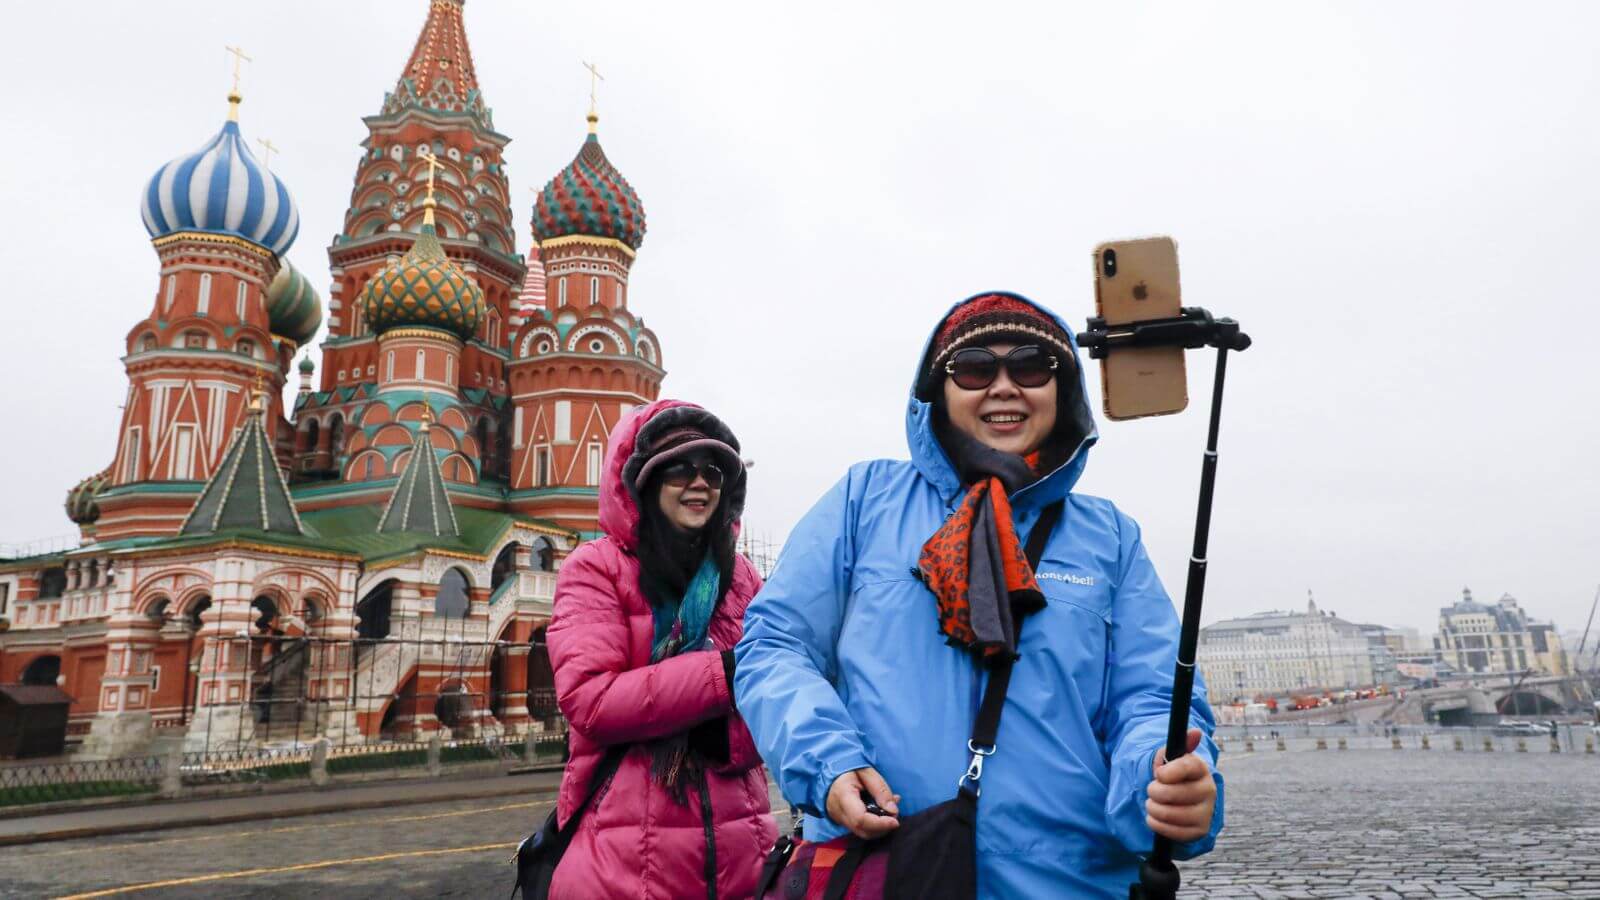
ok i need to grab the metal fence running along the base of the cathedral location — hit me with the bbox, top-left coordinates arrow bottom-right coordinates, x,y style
0,627 -> 566,809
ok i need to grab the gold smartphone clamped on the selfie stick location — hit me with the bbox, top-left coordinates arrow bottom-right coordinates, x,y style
1094,237 -> 1189,420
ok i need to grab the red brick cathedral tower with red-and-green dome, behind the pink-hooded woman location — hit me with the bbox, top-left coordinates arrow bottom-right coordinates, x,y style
507,109 -> 666,535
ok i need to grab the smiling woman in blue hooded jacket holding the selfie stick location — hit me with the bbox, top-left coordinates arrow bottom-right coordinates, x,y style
734,293 -> 1222,897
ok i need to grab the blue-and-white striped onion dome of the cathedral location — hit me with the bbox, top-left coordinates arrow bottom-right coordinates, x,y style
142,120 -> 299,256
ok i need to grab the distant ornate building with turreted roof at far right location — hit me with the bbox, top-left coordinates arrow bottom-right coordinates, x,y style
1434,588 -> 1570,676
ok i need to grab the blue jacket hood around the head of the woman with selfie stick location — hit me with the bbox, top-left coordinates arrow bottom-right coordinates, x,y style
908,291 -> 1099,509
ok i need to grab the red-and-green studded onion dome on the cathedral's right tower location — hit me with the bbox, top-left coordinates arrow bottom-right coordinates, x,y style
533,124 -> 645,250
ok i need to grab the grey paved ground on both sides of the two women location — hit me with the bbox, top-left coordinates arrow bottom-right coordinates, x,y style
0,749 -> 1600,900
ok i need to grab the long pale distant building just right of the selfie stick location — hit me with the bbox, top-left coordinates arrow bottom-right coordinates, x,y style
1200,601 -> 1394,701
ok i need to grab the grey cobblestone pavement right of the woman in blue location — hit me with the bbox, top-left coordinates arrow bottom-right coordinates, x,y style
1182,749 -> 1600,900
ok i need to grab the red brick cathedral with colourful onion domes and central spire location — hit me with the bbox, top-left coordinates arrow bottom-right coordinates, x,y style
0,0 -> 666,756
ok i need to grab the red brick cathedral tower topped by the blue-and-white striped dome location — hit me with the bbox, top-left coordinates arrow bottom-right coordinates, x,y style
94,85 -> 305,540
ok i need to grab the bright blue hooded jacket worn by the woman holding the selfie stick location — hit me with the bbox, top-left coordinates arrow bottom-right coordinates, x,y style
734,291 -> 1222,898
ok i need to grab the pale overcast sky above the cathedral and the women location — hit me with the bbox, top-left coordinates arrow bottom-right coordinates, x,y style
0,0 -> 1600,633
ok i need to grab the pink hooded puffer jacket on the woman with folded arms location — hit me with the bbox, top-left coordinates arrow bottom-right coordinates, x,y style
547,400 -> 778,900
